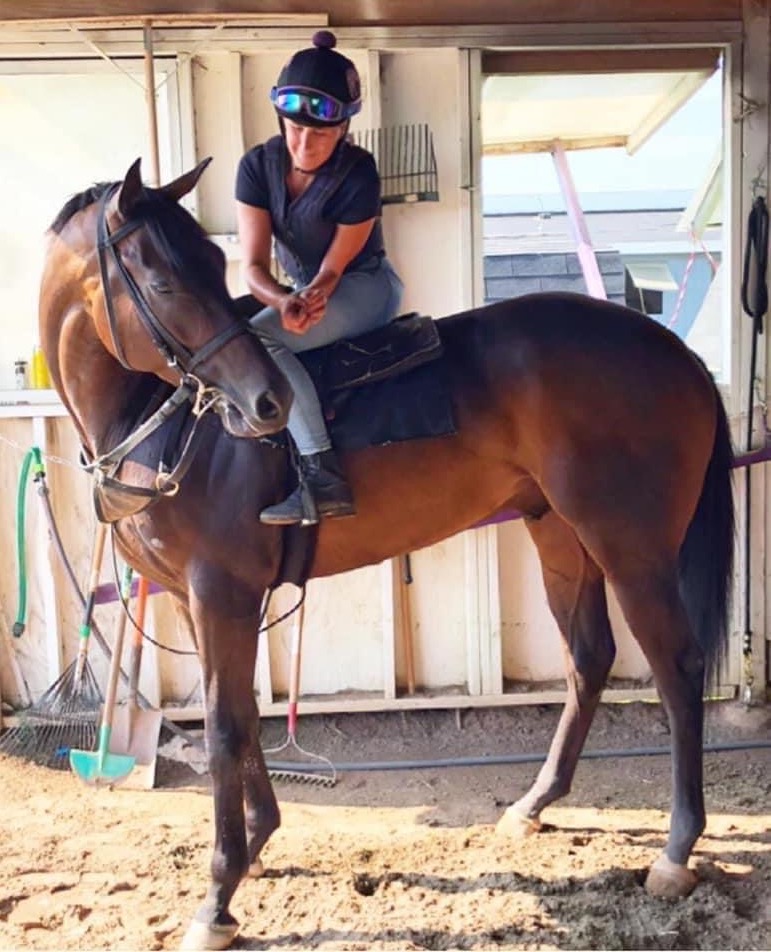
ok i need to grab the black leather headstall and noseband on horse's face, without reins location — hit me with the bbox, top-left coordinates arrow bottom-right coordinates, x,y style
97,185 -> 248,378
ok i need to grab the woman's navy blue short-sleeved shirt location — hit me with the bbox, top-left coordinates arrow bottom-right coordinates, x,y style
236,136 -> 384,285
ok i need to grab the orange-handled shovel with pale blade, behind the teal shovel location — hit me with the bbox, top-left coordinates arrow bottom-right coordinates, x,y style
112,576 -> 163,790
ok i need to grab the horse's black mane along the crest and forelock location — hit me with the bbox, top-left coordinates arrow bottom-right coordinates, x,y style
51,182 -> 230,301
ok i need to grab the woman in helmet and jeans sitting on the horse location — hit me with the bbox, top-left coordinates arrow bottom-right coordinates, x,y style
236,30 -> 402,525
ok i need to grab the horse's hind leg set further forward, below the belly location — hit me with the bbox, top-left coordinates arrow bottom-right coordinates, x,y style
498,512 -> 616,835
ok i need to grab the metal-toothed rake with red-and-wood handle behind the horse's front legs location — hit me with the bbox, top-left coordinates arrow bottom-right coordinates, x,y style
263,603 -> 337,787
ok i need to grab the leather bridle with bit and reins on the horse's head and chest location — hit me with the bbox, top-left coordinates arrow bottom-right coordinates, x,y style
83,185 -> 248,505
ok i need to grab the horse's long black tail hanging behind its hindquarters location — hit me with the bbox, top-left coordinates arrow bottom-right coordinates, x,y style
679,387 -> 735,684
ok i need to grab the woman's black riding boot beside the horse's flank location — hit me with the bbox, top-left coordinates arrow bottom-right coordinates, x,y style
260,450 -> 356,526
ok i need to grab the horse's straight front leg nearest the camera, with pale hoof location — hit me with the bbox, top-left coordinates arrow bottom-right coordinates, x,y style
182,579 -> 270,950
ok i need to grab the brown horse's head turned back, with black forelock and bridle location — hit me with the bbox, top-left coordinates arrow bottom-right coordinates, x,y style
94,159 -> 291,437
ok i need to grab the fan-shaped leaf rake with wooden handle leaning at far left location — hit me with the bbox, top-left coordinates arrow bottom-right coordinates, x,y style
0,510 -> 107,770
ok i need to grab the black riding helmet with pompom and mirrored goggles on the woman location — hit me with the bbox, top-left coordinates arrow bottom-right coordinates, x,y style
270,30 -> 361,127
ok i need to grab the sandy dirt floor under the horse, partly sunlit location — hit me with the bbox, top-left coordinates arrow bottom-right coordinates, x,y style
0,704 -> 771,950
